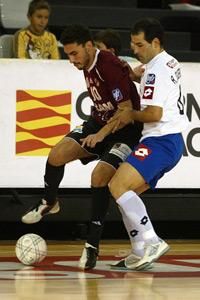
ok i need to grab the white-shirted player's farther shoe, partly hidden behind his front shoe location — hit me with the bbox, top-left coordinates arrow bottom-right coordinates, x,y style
110,253 -> 153,271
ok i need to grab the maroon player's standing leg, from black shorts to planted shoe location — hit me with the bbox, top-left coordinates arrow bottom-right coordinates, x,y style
80,123 -> 142,269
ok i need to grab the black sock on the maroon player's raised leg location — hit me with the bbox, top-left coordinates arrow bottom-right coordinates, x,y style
44,161 -> 65,205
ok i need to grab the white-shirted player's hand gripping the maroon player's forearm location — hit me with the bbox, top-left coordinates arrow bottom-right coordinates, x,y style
108,107 -> 133,133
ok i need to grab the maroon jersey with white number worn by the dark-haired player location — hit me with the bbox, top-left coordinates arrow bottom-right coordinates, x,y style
84,50 -> 140,125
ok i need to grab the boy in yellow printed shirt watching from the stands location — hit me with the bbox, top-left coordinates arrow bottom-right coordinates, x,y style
14,0 -> 60,59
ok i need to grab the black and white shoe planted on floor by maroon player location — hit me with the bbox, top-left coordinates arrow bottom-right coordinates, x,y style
79,243 -> 99,270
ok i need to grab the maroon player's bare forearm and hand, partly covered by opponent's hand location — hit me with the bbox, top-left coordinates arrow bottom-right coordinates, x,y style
81,100 -> 132,148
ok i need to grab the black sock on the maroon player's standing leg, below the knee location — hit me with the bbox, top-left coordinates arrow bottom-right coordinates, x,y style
87,186 -> 110,248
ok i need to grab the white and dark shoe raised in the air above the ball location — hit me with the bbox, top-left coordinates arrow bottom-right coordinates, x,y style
21,199 -> 60,224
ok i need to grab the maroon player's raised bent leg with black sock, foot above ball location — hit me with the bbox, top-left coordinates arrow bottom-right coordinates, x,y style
22,119 -> 101,224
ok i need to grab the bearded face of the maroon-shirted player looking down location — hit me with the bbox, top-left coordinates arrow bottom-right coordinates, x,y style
64,43 -> 91,70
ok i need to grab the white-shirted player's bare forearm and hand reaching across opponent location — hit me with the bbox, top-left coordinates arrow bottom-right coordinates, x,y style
108,105 -> 163,132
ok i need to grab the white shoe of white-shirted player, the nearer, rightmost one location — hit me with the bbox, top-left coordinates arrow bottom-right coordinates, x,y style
132,239 -> 170,271
